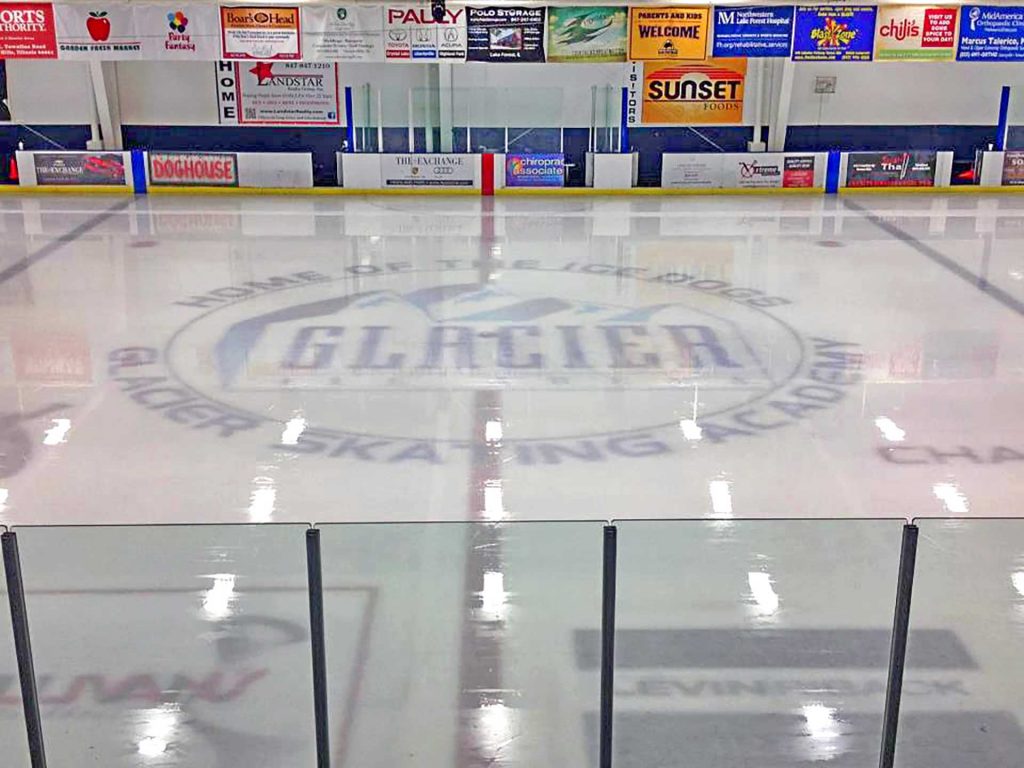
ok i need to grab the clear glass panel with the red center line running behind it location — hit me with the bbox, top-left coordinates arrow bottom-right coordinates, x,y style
321,523 -> 601,768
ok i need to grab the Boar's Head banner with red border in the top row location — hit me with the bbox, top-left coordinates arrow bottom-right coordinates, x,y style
220,5 -> 302,60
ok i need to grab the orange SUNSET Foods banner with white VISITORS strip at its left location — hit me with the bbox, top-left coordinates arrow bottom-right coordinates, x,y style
627,58 -> 746,125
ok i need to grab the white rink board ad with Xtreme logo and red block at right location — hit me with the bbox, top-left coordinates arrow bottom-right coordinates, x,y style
662,153 -> 818,189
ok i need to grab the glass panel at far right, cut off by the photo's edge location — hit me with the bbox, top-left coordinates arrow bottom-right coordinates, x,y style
896,520 -> 1024,768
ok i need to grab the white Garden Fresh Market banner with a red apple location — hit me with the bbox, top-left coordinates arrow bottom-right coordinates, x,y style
53,4 -> 142,61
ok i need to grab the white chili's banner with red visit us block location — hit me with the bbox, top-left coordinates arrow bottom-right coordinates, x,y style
874,5 -> 959,61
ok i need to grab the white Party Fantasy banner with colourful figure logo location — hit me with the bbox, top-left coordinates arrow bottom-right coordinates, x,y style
135,5 -> 220,61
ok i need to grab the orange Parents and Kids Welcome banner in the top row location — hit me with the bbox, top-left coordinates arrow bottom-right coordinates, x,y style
629,5 -> 711,61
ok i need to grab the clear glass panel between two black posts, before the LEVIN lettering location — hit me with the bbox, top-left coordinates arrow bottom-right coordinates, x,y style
606,519 -> 901,768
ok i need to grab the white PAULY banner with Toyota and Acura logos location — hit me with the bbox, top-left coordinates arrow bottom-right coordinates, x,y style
384,4 -> 466,61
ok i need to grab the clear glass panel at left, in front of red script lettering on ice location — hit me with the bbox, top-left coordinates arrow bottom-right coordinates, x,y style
17,525 -> 315,768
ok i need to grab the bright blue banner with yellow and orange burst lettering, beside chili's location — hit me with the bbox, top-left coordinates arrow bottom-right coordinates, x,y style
793,5 -> 878,61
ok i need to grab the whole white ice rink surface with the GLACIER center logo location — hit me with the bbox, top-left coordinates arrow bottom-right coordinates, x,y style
0,196 -> 1024,768
